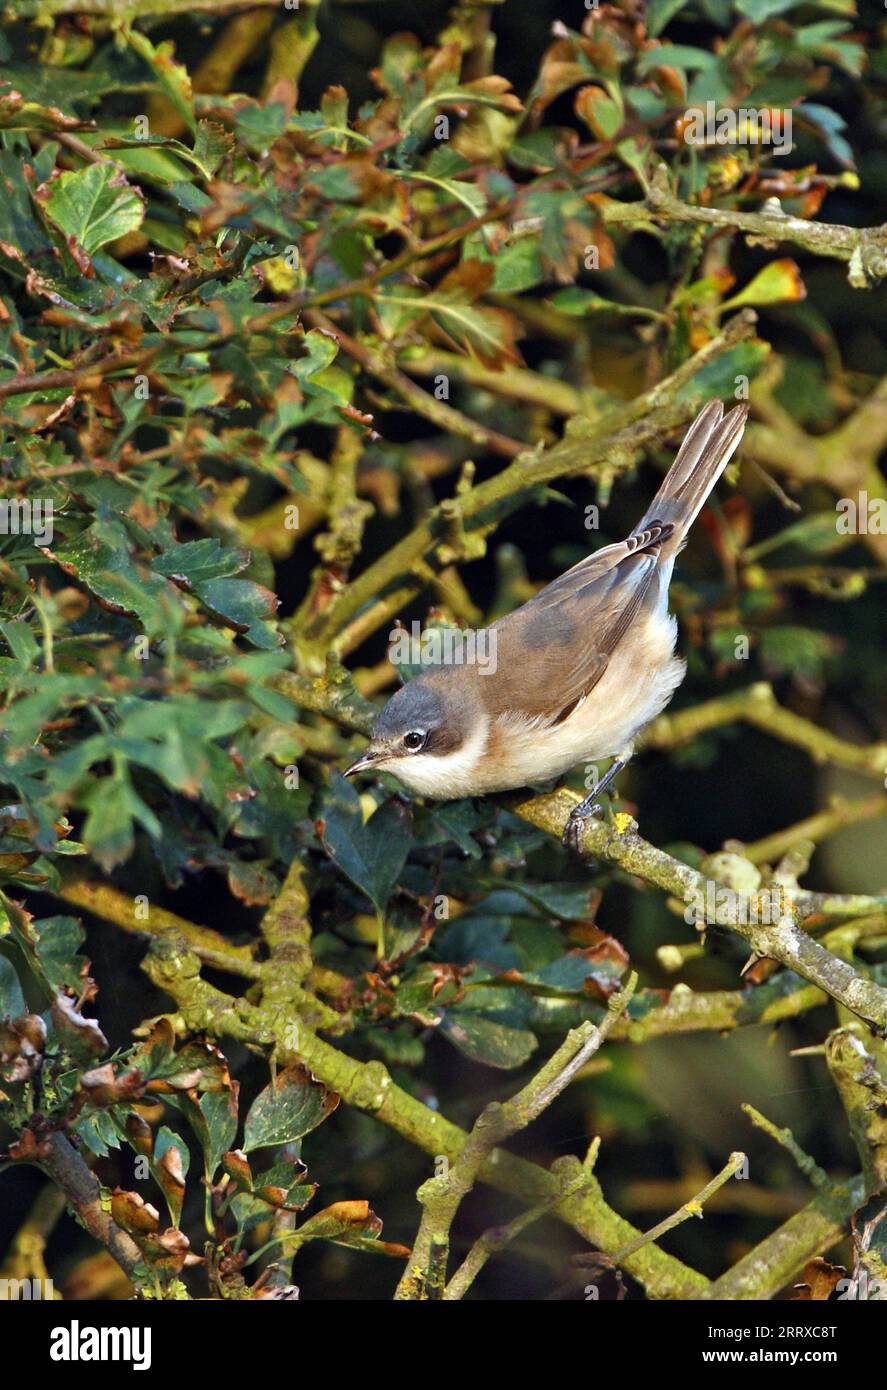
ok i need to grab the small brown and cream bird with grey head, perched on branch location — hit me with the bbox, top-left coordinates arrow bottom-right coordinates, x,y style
345,400 -> 748,849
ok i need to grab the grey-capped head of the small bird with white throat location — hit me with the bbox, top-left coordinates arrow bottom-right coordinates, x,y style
345,676 -> 486,799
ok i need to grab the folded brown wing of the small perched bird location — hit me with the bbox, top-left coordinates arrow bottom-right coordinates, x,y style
484,524 -> 672,724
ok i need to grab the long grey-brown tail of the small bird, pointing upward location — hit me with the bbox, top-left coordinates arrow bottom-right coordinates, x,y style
633,400 -> 748,547
